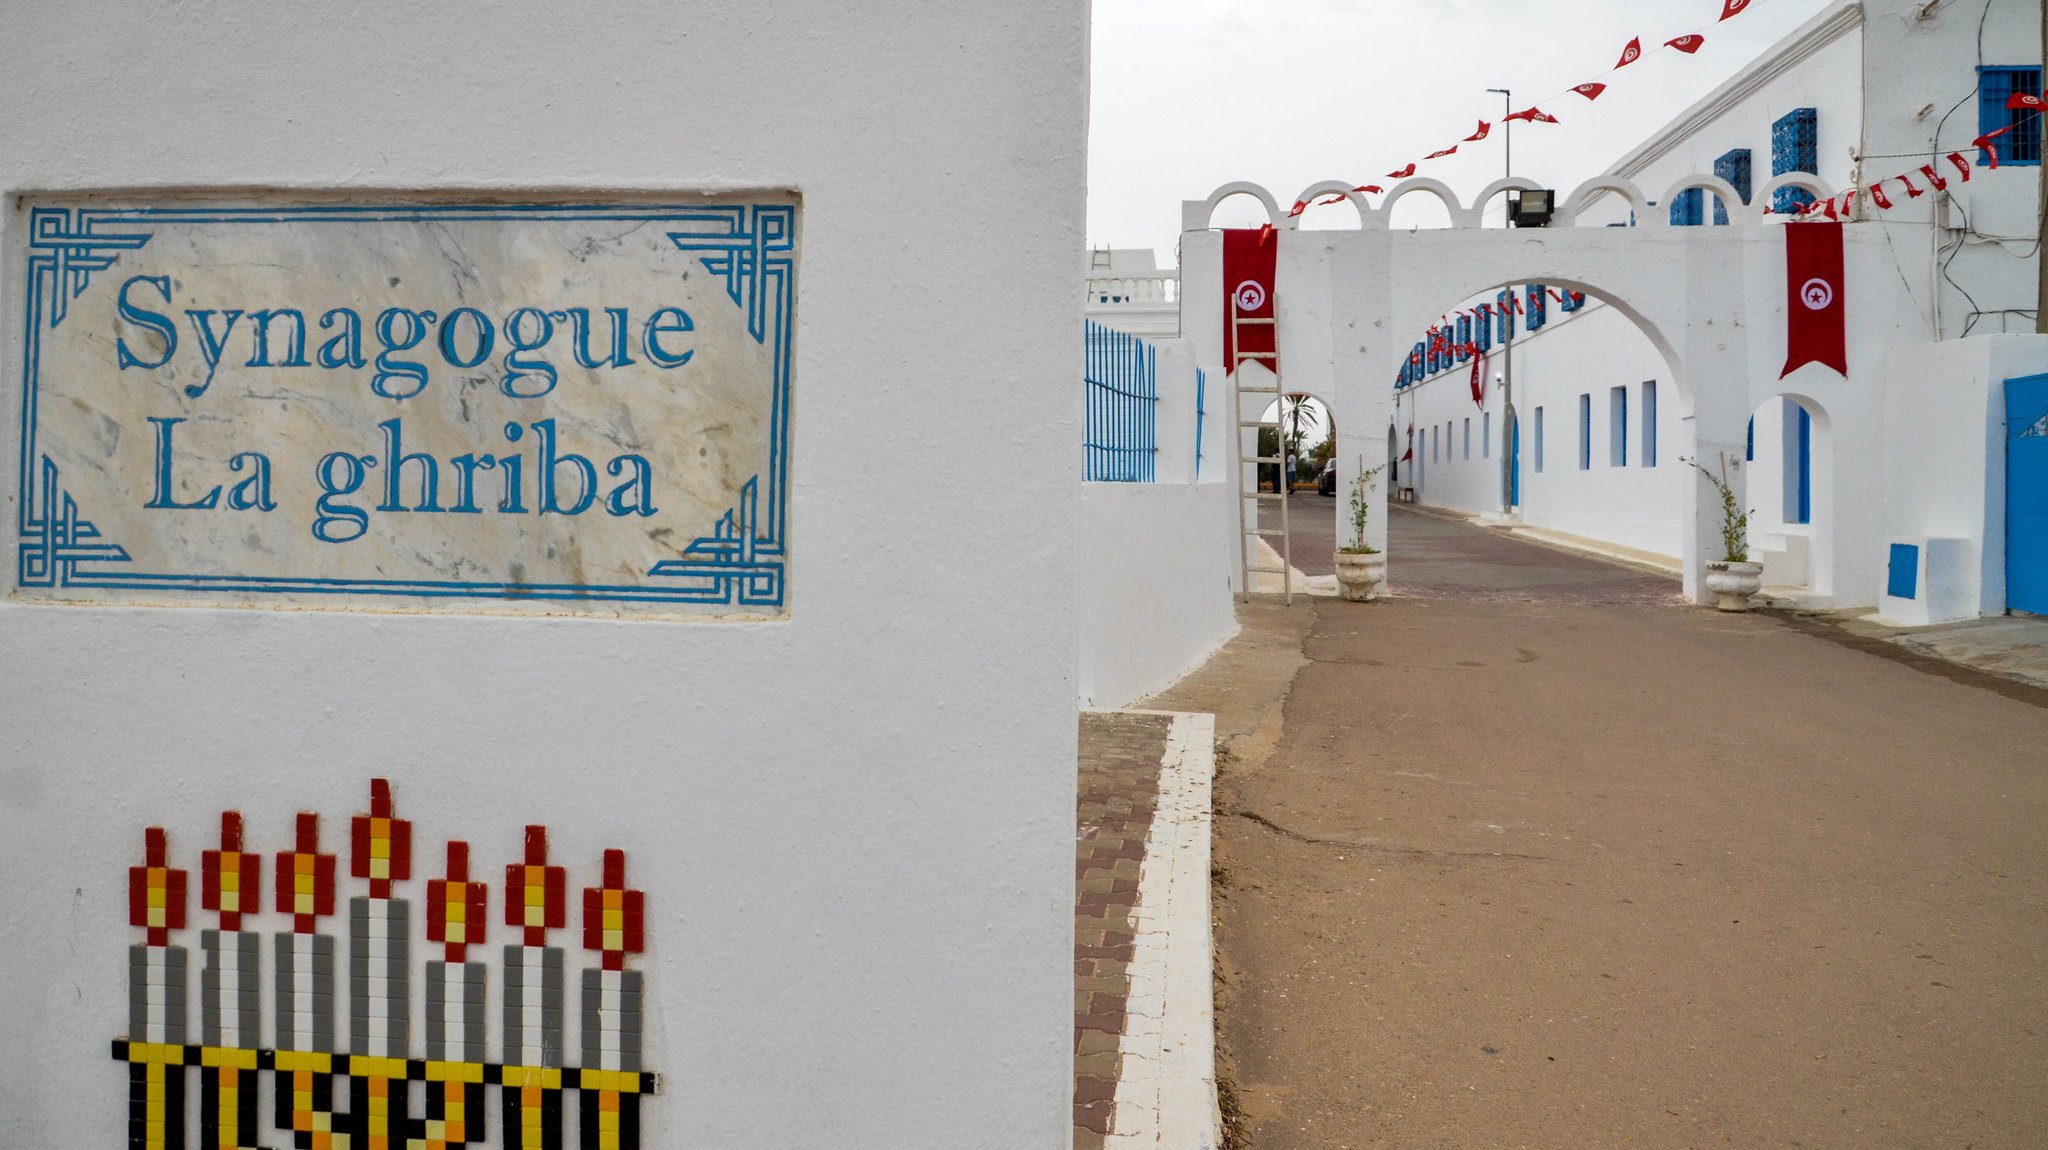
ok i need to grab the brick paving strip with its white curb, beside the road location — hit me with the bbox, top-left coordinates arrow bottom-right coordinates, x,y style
1073,712 -> 1221,1150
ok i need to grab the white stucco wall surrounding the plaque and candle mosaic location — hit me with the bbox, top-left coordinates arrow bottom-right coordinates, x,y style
0,0 -> 1087,1150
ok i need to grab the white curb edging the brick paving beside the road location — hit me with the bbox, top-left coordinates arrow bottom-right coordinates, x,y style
1104,710 -> 1223,1150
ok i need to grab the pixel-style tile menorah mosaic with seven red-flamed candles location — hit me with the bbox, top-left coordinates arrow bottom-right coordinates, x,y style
113,780 -> 662,1150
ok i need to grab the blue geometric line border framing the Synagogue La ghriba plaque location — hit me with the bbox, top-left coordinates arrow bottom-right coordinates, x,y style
14,205 -> 797,608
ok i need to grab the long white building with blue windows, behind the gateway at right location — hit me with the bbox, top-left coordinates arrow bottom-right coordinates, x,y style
1384,0 -> 2048,620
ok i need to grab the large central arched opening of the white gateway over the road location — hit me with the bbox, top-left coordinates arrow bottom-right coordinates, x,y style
1391,280 -> 1696,560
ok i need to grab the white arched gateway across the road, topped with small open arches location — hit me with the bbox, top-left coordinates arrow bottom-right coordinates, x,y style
1182,174 -> 1875,602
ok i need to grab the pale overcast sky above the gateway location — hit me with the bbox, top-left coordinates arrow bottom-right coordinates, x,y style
1087,0 -> 1833,266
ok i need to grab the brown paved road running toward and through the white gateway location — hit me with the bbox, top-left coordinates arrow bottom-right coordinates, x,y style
1155,516 -> 2048,1150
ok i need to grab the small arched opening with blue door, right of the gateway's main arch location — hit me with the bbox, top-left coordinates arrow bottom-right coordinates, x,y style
1743,395 -> 1833,602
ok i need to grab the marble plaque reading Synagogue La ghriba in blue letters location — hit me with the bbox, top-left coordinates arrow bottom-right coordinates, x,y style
6,196 -> 799,618
